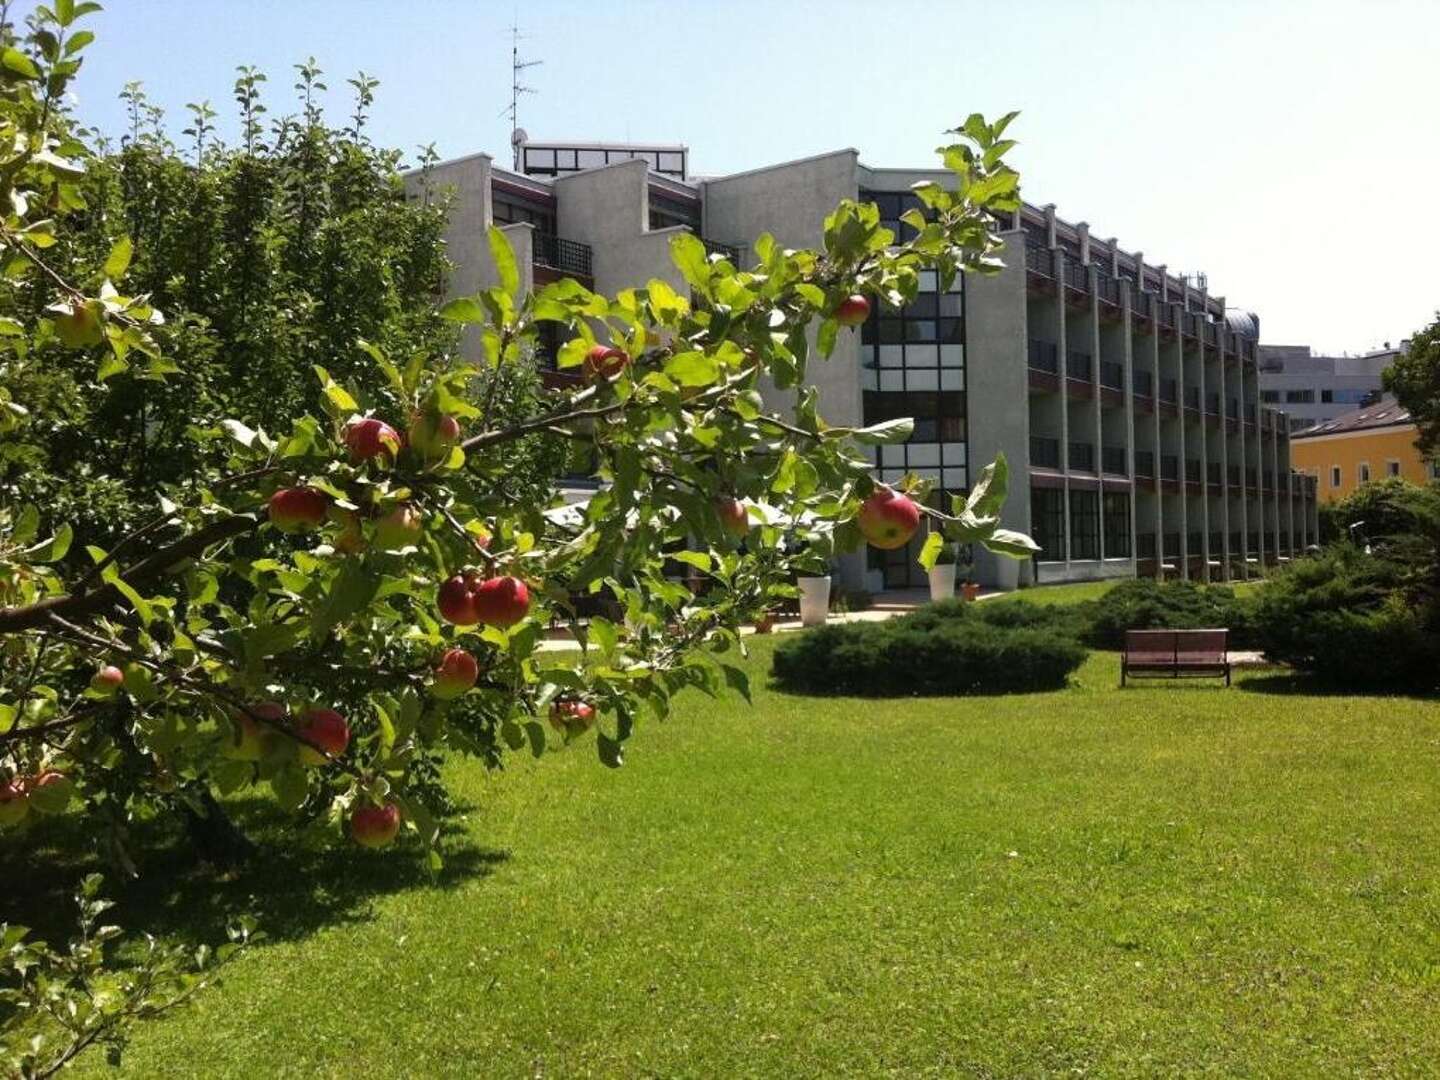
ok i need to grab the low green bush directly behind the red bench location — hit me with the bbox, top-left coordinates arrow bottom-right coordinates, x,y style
1074,577 -> 1254,649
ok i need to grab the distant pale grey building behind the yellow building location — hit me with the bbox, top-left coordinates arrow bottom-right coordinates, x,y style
1259,341 -> 1405,431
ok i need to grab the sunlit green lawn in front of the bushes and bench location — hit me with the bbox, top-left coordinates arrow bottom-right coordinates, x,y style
64,639 -> 1440,1077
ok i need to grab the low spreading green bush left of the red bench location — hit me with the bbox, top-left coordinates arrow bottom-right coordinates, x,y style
772,600 -> 1086,697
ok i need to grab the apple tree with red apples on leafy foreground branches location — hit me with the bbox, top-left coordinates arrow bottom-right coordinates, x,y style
0,1 -> 1034,1071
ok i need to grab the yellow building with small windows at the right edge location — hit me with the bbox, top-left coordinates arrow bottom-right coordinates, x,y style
1290,395 -> 1440,503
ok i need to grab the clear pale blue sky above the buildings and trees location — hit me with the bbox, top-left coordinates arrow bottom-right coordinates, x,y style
39,0 -> 1440,351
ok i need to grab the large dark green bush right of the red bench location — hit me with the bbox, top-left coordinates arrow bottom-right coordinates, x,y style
1253,544 -> 1440,691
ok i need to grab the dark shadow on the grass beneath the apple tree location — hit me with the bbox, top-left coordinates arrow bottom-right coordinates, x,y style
0,798 -> 510,945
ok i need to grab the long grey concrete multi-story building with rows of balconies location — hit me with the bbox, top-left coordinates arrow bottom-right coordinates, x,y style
412,143 -> 1318,590
